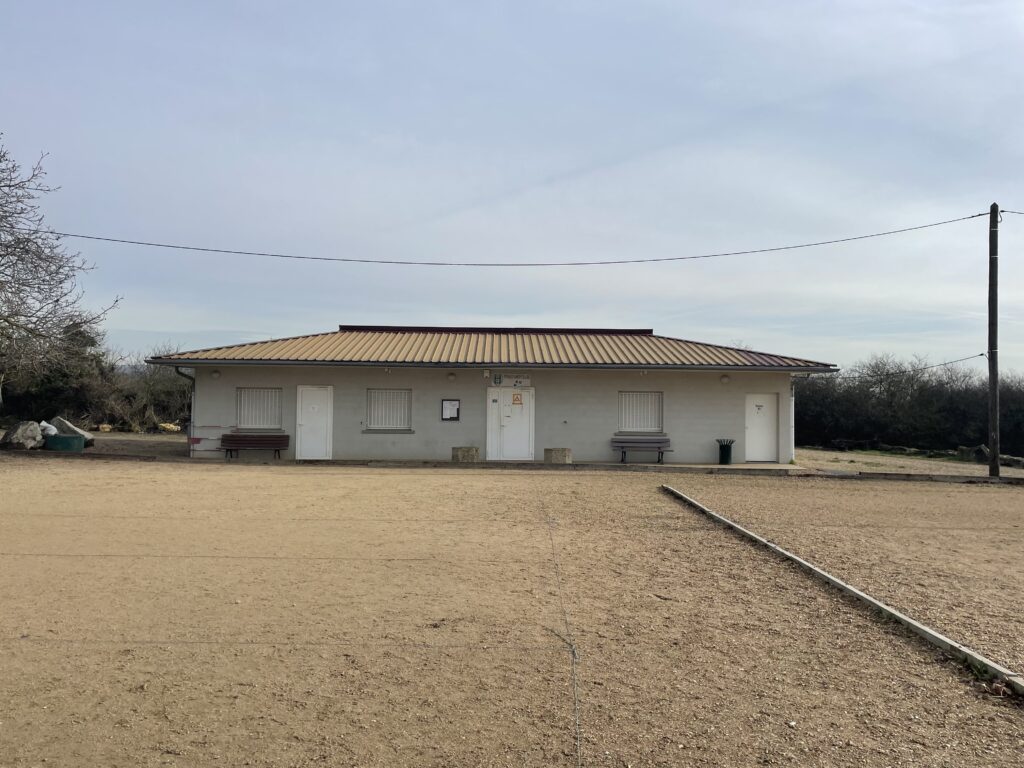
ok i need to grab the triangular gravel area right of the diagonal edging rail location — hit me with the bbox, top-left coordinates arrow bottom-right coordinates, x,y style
668,476 -> 1024,672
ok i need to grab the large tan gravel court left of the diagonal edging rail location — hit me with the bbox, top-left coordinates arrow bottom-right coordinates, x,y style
0,456 -> 1024,766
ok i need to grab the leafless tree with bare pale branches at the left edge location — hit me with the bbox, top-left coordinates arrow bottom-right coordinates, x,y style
0,135 -> 118,404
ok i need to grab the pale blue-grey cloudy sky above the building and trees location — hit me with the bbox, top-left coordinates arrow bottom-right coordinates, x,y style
0,0 -> 1024,371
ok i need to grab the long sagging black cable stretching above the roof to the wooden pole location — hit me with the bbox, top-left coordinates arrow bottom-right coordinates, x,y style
13,212 -> 988,267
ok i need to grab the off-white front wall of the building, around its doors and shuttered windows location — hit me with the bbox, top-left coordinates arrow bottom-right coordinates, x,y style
191,366 -> 794,464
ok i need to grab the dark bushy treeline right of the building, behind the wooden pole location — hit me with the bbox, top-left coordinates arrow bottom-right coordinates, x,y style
796,356 -> 1024,456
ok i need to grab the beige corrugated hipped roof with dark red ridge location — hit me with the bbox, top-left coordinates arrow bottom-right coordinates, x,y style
150,326 -> 835,371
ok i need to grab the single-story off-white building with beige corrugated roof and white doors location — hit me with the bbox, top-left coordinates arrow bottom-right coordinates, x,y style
147,326 -> 837,463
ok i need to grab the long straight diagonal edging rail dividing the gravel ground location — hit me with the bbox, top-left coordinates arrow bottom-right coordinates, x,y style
662,485 -> 1024,696
